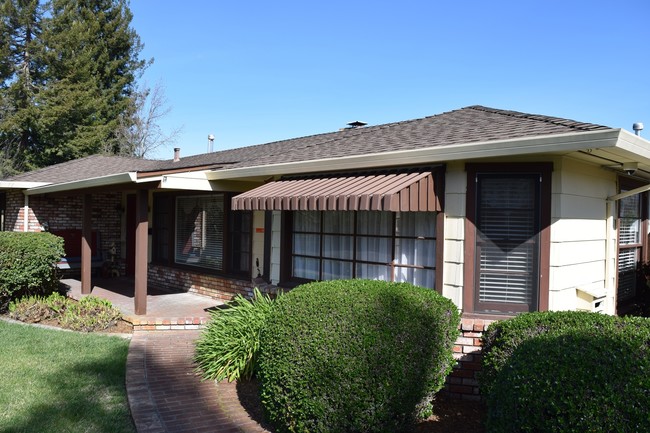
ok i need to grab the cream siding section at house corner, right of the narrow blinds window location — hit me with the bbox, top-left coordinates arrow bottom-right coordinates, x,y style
549,157 -> 617,314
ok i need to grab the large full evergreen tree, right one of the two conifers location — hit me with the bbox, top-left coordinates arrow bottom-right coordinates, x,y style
39,0 -> 147,166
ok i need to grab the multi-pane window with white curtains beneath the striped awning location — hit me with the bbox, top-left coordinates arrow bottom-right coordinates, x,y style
291,211 -> 437,288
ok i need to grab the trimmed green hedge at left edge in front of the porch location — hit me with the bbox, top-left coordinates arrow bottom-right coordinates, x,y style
0,232 -> 65,311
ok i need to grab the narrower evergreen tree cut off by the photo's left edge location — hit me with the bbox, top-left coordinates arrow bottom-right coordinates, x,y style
0,0 -> 45,176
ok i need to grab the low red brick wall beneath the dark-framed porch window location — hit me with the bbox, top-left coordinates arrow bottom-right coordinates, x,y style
147,263 -> 255,302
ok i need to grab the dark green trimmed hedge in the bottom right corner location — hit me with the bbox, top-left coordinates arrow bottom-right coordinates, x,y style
481,312 -> 650,433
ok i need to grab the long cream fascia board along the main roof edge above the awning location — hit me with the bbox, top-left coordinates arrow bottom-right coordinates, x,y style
206,129 -> 621,180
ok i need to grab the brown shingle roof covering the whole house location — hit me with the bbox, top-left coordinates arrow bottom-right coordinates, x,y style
2,105 -> 611,183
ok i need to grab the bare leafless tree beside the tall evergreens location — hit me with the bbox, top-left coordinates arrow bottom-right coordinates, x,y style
105,83 -> 180,158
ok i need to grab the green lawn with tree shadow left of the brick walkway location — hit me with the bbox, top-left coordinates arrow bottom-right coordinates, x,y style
0,321 -> 135,433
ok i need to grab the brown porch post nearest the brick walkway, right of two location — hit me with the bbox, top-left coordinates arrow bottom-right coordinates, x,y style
134,189 -> 149,315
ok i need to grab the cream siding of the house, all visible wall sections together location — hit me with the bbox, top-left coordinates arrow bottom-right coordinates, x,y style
264,156 -> 617,314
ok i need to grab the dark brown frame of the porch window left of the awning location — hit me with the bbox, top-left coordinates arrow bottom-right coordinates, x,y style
152,191 -> 253,279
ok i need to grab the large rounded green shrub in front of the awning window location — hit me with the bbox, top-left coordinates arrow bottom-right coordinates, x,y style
259,280 -> 460,433
